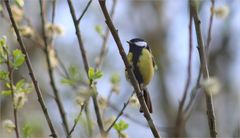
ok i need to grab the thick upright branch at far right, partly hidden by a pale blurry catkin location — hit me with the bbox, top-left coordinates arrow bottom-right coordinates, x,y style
190,1 -> 217,137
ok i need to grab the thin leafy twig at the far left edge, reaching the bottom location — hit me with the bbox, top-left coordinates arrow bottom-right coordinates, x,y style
3,47 -> 20,138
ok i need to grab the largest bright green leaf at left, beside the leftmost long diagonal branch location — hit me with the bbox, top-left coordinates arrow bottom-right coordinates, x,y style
13,49 -> 25,69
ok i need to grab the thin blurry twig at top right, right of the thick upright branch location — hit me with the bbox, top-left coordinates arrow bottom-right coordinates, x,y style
206,0 -> 215,52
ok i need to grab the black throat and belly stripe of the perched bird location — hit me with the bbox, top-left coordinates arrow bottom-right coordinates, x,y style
129,47 -> 143,84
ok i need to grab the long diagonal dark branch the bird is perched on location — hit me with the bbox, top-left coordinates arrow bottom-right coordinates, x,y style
99,0 -> 160,137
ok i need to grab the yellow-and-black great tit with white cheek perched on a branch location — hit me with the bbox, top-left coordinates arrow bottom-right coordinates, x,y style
126,38 -> 154,113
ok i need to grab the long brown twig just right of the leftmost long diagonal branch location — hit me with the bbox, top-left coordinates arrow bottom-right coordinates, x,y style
39,0 -> 69,134
